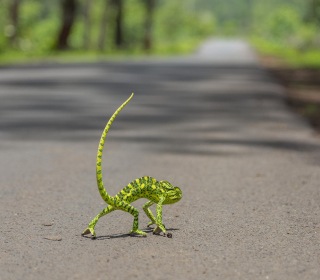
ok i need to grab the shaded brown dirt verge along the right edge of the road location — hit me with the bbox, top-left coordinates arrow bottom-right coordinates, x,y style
260,56 -> 320,134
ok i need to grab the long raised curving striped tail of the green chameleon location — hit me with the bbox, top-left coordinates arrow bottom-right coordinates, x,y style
97,93 -> 133,204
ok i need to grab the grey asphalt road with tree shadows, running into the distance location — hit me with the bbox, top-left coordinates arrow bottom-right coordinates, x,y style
0,40 -> 320,280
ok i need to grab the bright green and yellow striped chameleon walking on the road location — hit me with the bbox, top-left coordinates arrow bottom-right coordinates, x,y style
82,93 -> 182,239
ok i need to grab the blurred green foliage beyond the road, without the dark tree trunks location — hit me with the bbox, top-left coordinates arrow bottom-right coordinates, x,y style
0,0 -> 320,63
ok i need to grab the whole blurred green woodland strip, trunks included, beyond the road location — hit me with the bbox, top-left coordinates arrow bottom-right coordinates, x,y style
0,0 -> 320,67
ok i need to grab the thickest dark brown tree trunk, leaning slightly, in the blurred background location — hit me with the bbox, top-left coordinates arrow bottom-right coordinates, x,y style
56,0 -> 77,50
